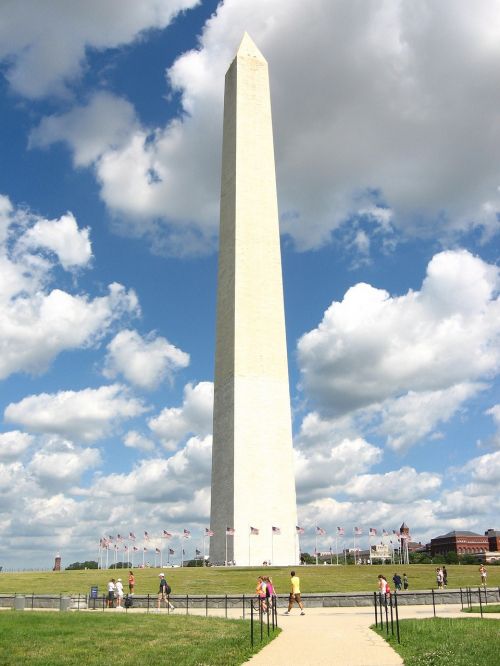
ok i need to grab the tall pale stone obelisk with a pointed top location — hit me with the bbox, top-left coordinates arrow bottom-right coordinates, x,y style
210,33 -> 298,565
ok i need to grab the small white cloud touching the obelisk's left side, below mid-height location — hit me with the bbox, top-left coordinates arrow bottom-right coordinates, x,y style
148,382 -> 214,450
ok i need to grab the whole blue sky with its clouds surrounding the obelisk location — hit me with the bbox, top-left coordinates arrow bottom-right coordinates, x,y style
0,0 -> 500,567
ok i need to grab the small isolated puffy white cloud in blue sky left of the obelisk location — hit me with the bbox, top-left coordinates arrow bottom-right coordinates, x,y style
104,330 -> 189,389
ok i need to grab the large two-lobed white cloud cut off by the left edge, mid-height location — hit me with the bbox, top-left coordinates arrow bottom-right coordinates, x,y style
0,197 -> 139,379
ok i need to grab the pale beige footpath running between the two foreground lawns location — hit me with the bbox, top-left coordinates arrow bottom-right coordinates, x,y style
247,605 -> 474,666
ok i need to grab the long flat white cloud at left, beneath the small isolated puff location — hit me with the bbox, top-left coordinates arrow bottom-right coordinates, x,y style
4,384 -> 146,442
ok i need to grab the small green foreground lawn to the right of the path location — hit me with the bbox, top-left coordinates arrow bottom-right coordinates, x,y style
374,618 -> 500,666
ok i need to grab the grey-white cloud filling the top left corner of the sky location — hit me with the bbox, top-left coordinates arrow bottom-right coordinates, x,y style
0,0 -> 198,98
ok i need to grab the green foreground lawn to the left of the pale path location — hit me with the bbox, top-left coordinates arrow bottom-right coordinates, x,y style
0,611 -> 278,666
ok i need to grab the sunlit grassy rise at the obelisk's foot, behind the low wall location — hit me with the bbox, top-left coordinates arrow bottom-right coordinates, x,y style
0,564 -> 500,595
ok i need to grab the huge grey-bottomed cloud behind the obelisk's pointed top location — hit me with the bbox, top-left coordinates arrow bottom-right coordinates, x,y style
32,0 -> 500,256
